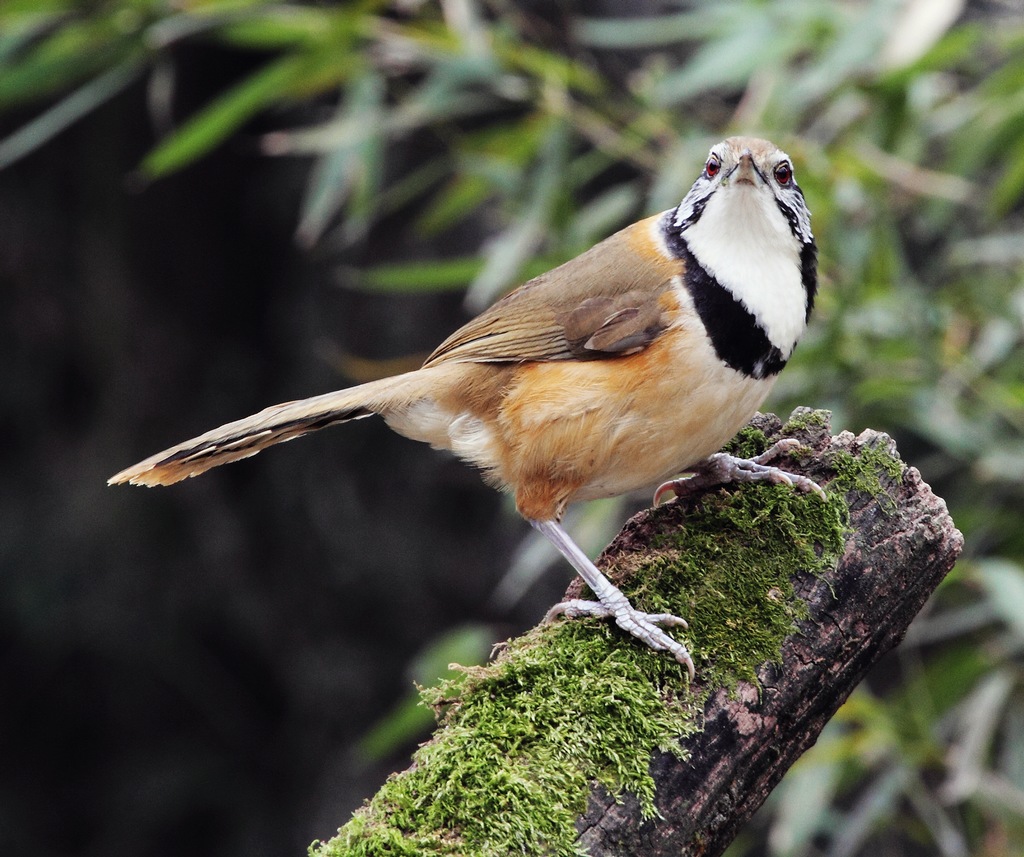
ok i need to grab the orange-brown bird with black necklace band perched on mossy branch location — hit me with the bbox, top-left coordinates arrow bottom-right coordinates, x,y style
109,136 -> 822,680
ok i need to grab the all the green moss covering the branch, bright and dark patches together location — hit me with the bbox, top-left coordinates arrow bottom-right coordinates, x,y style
310,411 -> 872,857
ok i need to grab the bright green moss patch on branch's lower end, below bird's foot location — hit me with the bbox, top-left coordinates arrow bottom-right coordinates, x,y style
312,622 -> 696,857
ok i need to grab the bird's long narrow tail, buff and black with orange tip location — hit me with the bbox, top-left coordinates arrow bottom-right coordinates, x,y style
106,373 -> 403,485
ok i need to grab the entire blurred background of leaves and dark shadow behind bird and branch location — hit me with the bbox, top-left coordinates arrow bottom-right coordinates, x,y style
0,0 -> 1024,857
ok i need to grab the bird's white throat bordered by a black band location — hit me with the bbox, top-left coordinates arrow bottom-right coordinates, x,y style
683,183 -> 807,359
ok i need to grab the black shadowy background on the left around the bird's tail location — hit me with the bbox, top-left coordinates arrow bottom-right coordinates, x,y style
0,50 -> 569,855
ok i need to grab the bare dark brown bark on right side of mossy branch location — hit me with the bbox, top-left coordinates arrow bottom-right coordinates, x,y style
577,416 -> 963,857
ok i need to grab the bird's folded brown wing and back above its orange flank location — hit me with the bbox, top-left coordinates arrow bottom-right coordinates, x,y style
424,215 -> 682,366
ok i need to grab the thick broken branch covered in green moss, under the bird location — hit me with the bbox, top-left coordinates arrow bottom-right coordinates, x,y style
310,410 -> 963,857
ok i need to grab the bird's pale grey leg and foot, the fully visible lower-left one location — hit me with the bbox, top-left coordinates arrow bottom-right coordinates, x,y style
530,520 -> 694,679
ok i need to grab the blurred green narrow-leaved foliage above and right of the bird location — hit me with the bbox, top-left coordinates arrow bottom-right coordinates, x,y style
6,0 -> 1024,857
